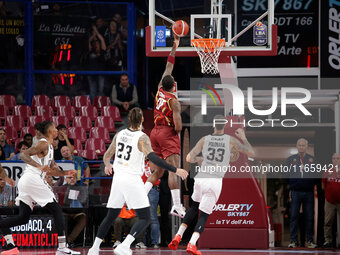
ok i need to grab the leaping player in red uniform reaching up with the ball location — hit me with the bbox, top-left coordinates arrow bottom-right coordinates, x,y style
145,37 -> 185,218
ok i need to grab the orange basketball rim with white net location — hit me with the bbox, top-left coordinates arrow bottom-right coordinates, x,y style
191,38 -> 225,74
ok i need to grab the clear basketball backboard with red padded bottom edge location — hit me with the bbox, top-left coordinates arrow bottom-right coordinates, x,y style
145,0 -> 277,57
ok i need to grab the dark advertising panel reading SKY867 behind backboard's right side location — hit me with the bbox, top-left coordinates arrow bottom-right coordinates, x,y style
236,0 -> 320,68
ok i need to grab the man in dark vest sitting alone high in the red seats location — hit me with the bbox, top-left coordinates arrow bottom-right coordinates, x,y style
111,74 -> 138,112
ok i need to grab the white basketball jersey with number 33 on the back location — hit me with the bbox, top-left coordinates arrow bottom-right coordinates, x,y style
197,135 -> 230,177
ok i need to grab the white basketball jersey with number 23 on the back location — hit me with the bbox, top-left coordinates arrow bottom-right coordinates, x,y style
113,128 -> 145,176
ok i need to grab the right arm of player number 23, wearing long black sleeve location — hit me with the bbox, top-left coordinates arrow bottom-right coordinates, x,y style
138,134 -> 188,180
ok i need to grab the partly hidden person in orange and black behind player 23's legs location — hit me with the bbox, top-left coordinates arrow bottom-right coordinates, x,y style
113,205 -> 147,249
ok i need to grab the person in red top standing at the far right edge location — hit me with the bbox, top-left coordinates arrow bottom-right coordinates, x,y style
322,153 -> 340,248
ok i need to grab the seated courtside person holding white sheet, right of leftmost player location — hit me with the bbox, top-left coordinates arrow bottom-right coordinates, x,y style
64,176 -> 88,247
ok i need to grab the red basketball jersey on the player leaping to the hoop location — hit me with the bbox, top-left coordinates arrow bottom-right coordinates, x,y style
153,88 -> 177,127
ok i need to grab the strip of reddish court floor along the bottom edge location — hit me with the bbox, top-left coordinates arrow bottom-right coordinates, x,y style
12,247 -> 340,255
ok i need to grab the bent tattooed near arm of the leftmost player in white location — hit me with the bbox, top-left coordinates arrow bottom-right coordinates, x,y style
20,141 -> 49,171
